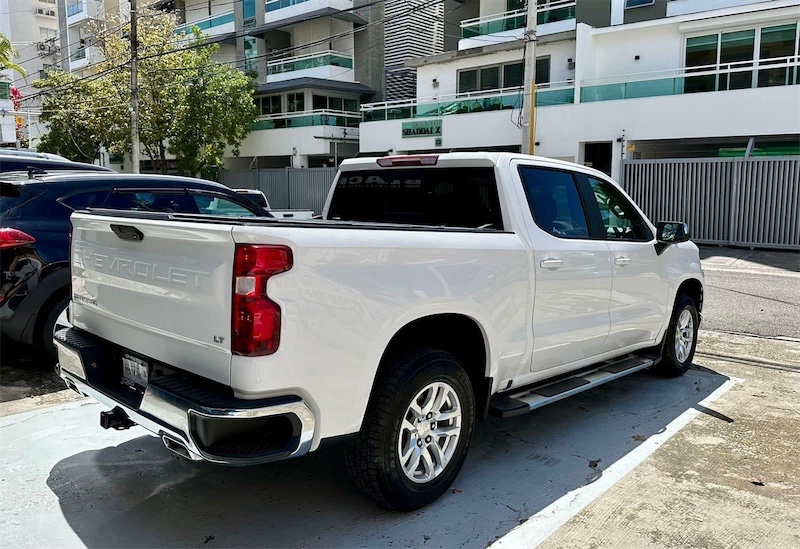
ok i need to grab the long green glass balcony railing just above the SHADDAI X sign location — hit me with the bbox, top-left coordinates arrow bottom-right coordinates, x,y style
361,83 -> 575,122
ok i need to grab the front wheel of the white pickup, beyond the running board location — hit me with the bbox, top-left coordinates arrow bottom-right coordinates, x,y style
653,295 -> 699,377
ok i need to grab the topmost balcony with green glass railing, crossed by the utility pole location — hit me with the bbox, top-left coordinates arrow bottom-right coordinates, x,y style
458,0 -> 575,50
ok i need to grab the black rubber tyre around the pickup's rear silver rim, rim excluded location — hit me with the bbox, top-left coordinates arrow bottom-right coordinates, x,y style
345,349 -> 475,511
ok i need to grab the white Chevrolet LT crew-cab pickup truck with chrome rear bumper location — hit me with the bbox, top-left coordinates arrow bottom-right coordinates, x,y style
55,153 -> 703,510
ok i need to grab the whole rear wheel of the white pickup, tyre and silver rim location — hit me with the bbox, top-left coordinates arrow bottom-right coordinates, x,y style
345,349 -> 475,511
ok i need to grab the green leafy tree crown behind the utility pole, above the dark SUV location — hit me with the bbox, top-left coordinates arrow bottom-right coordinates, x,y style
34,8 -> 258,175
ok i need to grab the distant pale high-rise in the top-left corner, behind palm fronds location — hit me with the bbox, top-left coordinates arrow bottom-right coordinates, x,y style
0,0 -> 60,147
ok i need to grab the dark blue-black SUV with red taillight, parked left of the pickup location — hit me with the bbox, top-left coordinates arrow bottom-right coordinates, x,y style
0,170 -> 271,357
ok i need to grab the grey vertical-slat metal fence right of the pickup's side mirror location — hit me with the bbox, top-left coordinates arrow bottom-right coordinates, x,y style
624,156 -> 800,249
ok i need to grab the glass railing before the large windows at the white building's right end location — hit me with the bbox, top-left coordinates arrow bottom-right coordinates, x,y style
581,56 -> 800,103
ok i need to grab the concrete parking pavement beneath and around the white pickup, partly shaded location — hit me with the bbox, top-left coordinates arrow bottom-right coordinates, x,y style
0,333 -> 800,547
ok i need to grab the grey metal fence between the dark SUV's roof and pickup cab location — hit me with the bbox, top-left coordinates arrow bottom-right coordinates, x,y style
220,168 -> 336,214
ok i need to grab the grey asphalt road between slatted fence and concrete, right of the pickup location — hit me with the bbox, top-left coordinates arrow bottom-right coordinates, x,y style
702,270 -> 800,338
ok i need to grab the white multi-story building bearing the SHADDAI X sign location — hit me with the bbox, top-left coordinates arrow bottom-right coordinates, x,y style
360,0 -> 800,177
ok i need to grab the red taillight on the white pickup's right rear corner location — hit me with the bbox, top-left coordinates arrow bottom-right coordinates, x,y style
231,244 -> 292,356
